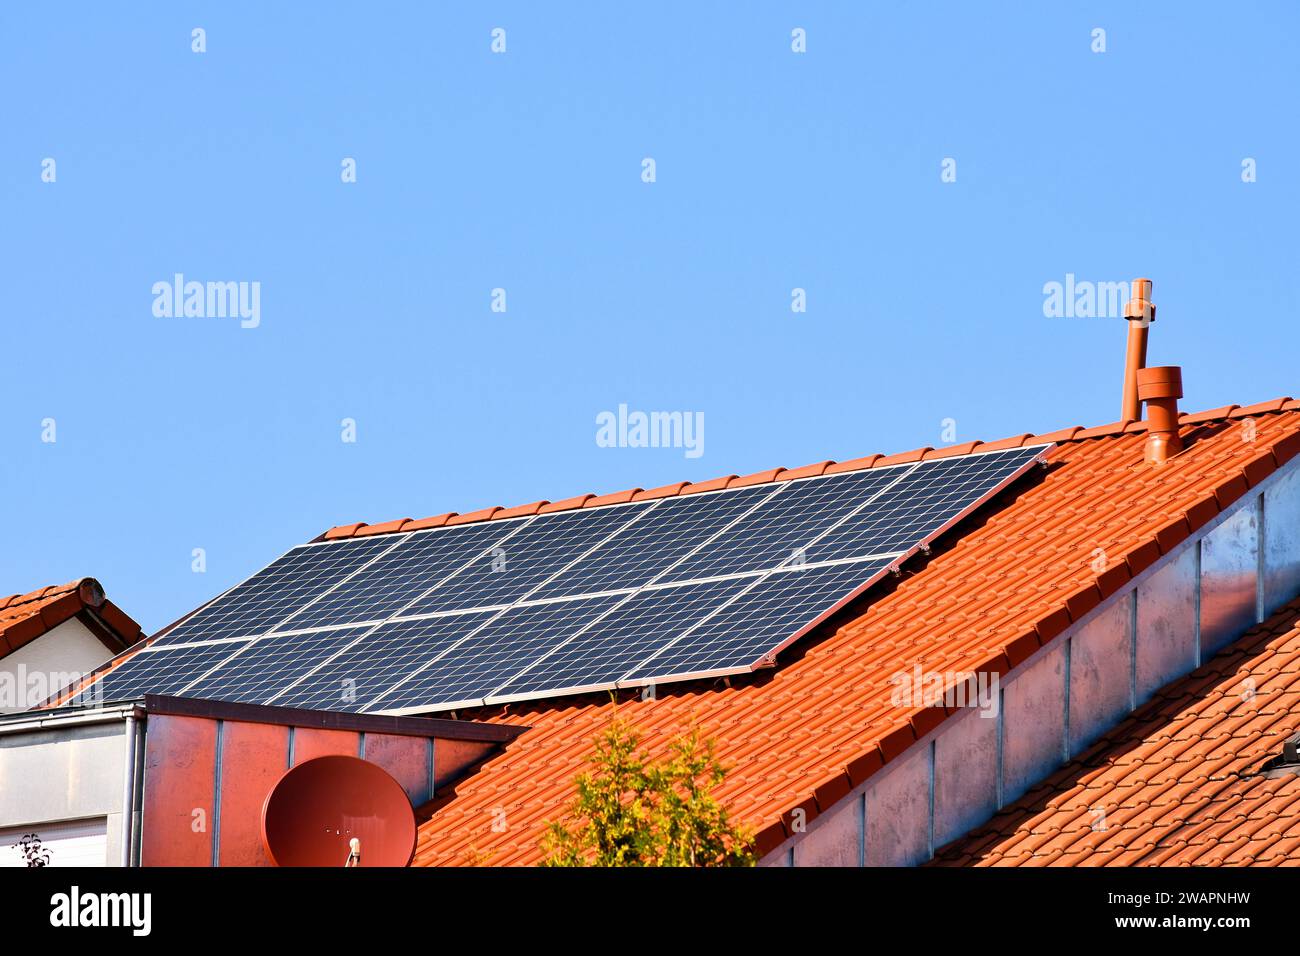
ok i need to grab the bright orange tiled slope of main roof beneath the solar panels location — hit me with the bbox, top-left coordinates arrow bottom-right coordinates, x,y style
410,399 -> 1300,865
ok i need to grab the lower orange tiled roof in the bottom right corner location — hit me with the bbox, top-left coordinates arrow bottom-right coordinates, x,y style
936,600 -> 1300,866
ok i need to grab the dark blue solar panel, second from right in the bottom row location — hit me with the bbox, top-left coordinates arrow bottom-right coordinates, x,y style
491,579 -> 753,698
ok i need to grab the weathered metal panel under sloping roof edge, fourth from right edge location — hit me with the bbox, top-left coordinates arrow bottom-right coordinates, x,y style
1070,593 -> 1134,753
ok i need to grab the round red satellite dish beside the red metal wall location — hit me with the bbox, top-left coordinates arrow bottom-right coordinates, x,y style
261,757 -> 415,866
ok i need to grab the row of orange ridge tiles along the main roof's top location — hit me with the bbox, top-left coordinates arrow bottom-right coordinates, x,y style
317,395 -> 1300,541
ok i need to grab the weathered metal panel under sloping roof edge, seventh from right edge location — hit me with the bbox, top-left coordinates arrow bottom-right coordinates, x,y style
868,747 -> 931,866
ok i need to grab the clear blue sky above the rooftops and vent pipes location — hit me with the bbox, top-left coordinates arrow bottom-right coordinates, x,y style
0,1 -> 1300,631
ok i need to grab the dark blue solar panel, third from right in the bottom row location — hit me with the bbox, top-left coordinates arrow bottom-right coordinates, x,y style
367,597 -> 619,710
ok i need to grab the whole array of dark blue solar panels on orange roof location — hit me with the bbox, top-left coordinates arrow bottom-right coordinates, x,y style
89,446 -> 1044,713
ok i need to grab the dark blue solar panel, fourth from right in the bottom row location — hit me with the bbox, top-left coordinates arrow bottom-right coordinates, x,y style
273,611 -> 497,710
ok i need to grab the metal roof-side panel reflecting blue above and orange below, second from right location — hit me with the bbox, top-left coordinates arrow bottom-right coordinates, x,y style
1201,497 -> 1260,661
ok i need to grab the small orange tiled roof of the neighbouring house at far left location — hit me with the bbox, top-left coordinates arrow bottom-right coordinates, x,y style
0,578 -> 143,658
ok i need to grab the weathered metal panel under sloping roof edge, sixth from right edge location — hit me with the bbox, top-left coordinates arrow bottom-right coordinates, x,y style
935,710 -> 998,847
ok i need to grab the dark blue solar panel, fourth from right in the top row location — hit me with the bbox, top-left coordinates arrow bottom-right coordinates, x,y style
404,502 -> 650,615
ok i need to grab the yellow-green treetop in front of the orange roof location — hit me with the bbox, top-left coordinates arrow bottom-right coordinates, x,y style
542,718 -> 754,866
